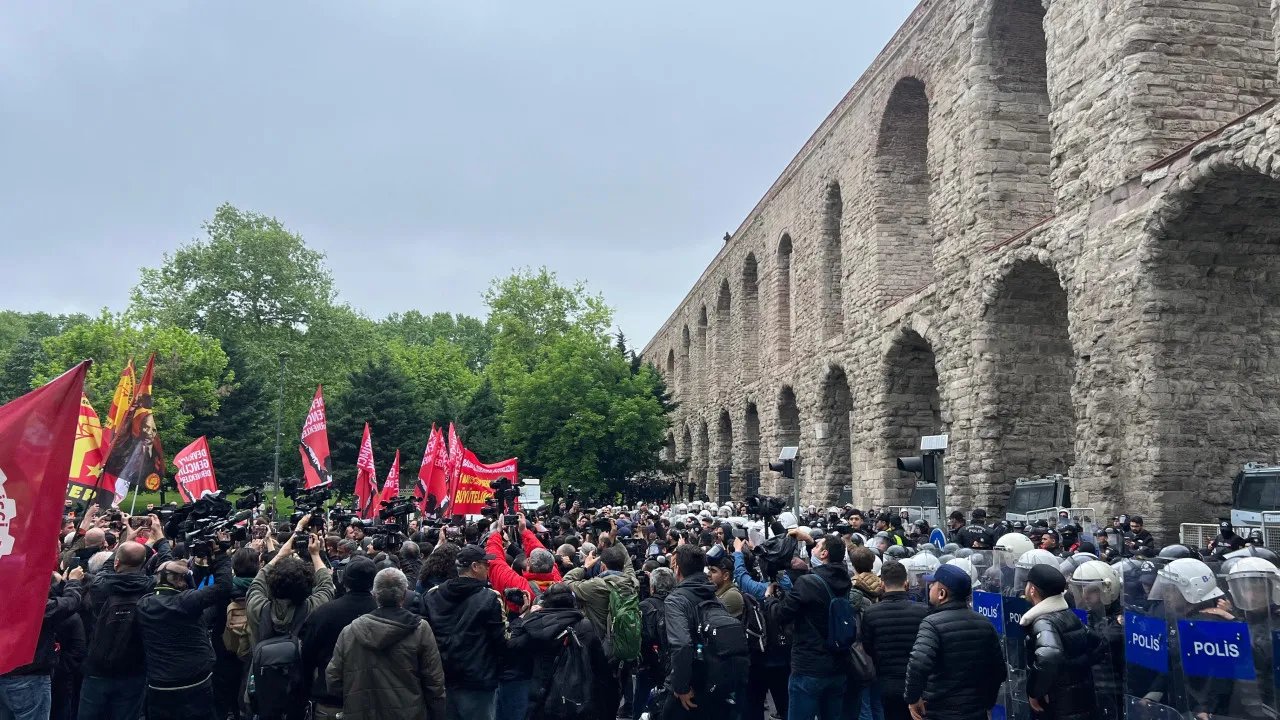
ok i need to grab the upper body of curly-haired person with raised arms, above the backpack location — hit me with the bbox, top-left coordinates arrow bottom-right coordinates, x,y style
248,515 -> 334,644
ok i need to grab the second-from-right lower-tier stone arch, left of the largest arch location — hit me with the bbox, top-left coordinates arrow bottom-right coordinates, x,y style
975,258 -> 1075,511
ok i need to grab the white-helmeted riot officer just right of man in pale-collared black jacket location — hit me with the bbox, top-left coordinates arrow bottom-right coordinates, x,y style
1068,560 -> 1124,720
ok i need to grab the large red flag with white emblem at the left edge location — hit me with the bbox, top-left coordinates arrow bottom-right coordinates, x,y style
0,360 -> 90,675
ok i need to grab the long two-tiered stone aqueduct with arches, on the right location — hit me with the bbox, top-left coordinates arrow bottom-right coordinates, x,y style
644,0 -> 1280,532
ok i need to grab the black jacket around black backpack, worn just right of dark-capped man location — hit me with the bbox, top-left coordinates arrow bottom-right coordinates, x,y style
512,609 -> 612,720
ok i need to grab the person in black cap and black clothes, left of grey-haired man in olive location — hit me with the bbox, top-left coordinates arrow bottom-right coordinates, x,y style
298,557 -> 378,720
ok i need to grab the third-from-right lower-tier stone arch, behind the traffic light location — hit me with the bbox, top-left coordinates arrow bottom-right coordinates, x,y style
870,328 -> 947,503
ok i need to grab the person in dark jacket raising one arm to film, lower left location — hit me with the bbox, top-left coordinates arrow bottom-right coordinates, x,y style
136,537 -> 232,720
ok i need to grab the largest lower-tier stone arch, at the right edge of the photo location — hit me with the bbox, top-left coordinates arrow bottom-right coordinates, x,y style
1126,165 -> 1280,517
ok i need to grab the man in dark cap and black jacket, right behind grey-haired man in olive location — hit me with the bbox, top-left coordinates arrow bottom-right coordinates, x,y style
424,544 -> 508,720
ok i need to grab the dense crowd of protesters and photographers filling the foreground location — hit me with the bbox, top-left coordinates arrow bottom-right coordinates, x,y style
10,498 -> 1280,720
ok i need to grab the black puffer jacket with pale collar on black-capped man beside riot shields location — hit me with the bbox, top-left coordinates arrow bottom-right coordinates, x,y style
1019,594 -> 1102,720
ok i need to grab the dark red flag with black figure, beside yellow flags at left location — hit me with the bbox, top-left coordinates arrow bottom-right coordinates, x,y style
93,355 -> 165,505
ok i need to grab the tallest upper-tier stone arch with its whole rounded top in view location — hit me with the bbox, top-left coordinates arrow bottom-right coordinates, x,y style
873,77 -> 933,300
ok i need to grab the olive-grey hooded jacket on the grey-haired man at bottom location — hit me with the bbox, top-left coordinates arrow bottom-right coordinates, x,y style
325,607 -> 444,720
